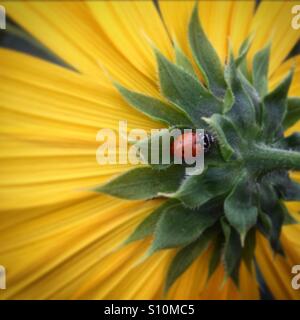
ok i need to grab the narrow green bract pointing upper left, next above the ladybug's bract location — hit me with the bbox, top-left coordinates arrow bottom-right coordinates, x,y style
114,83 -> 192,126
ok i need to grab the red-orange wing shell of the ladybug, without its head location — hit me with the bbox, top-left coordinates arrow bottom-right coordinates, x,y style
171,132 -> 203,159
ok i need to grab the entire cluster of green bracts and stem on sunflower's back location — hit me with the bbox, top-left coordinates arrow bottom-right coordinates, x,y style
97,5 -> 300,289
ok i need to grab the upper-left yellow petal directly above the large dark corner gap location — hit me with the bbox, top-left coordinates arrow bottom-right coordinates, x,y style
5,1 -> 157,94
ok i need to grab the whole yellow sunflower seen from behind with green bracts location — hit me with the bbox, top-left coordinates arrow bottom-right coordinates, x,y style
0,1 -> 300,299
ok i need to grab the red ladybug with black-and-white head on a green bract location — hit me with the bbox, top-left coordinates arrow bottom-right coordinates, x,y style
171,132 -> 215,159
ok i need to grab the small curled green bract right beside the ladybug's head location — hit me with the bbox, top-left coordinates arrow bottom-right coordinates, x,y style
203,114 -> 239,161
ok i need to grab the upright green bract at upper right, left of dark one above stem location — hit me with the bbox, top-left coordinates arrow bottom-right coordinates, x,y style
252,45 -> 271,98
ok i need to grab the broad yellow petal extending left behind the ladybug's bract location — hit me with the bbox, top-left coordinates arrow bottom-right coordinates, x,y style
0,49 -> 157,210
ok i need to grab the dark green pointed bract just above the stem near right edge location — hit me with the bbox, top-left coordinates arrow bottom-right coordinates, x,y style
263,71 -> 293,141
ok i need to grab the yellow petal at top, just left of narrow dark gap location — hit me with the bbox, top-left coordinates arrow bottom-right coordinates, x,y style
87,1 -> 172,88
